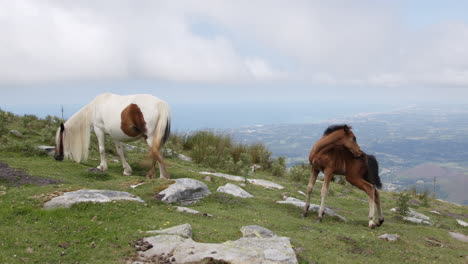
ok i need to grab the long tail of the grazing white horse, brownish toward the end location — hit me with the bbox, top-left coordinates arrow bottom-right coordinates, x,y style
150,102 -> 171,164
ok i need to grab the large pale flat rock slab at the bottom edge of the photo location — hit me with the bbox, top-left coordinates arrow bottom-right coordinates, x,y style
133,224 -> 298,264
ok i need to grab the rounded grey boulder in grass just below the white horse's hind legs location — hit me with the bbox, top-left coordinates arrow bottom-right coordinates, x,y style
156,178 -> 211,205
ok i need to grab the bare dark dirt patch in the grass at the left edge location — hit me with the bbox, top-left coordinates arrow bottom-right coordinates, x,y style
0,162 -> 62,187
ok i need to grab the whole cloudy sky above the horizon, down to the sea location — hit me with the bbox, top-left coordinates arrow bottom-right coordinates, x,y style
0,0 -> 468,127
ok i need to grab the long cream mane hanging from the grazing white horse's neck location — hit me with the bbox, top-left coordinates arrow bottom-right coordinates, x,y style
63,101 -> 94,163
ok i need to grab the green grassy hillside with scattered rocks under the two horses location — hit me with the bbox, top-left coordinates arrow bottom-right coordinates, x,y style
0,110 -> 468,263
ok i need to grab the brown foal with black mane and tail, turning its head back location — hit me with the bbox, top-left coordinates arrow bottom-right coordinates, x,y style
303,125 -> 384,228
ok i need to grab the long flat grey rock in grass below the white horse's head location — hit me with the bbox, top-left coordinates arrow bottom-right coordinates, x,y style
44,189 -> 145,209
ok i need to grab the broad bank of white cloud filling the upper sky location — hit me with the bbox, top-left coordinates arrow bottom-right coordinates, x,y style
0,0 -> 468,92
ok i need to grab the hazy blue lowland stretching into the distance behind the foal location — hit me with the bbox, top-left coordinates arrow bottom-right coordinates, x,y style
228,106 -> 468,204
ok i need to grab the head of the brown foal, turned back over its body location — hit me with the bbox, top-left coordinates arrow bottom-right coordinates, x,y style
323,125 -> 364,158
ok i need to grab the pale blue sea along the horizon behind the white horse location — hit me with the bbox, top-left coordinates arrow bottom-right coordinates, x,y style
0,102 -> 402,132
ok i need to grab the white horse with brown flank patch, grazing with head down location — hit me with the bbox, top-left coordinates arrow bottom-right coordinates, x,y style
55,94 -> 171,179
